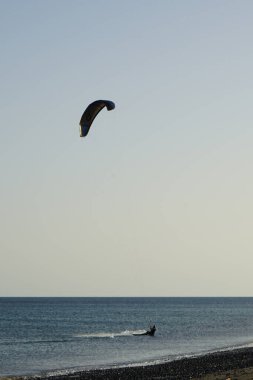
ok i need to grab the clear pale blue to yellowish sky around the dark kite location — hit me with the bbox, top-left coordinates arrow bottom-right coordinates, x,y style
0,0 -> 253,296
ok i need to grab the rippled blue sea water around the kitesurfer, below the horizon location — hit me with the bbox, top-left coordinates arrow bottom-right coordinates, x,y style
0,298 -> 253,376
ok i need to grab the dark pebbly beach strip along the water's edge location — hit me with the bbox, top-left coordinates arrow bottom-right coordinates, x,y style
0,347 -> 253,380
